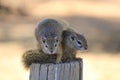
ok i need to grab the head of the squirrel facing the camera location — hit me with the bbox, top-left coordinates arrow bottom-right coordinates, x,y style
41,36 -> 60,54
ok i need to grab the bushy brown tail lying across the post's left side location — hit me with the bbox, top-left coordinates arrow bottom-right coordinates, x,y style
22,49 -> 56,69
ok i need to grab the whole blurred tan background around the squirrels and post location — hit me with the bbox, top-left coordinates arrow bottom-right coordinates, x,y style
0,0 -> 120,80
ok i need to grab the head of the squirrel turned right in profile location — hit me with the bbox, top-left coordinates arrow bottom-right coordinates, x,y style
63,32 -> 88,50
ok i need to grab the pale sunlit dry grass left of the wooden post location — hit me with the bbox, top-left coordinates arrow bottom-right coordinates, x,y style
0,43 -> 28,80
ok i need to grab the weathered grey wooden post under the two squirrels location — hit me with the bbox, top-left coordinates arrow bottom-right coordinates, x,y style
30,59 -> 83,80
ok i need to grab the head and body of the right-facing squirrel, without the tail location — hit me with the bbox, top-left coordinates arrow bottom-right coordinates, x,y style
62,29 -> 88,62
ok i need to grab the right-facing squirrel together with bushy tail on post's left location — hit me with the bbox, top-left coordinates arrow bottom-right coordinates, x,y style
22,29 -> 87,68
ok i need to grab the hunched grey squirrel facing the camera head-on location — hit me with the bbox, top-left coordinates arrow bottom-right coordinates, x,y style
35,18 -> 64,63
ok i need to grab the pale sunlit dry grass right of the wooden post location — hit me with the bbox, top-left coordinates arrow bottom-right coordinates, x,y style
79,52 -> 120,80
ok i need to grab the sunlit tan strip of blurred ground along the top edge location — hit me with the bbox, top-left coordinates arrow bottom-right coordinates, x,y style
1,0 -> 120,18
